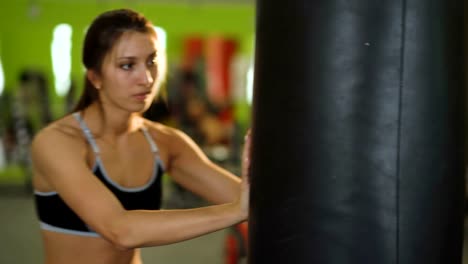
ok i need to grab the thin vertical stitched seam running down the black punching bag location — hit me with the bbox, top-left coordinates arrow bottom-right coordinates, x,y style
395,0 -> 406,264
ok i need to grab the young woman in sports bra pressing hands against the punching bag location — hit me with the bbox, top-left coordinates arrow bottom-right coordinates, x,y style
31,9 -> 250,264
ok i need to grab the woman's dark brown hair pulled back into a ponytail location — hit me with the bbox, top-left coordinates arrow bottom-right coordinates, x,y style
73,9 -> 156,112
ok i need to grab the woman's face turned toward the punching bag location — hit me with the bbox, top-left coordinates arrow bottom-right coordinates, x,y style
94,31 -> 158,112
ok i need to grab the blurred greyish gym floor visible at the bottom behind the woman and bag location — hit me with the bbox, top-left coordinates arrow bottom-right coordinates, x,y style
0,190 -> 468,264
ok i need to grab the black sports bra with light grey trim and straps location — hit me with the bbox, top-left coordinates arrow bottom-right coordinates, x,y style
34,113 -> 164,237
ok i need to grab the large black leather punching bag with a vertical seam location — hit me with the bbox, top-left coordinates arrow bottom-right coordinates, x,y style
248,0 -> 465,264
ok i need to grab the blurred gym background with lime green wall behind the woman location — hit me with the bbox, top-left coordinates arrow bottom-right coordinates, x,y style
0,0 -> 255,264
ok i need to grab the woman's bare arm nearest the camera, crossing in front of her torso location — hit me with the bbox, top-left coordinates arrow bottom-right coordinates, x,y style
32,126 -> 248,249
